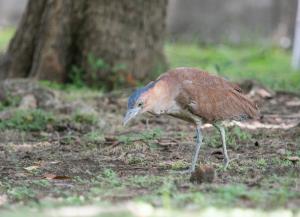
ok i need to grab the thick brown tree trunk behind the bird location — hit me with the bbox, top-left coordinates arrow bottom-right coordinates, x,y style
0,0 -> 167,88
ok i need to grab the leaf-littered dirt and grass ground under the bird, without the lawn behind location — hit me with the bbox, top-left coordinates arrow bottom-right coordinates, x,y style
0,80 -> 300,216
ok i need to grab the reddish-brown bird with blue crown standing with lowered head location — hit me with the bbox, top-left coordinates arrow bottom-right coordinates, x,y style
123,67 -> 259,173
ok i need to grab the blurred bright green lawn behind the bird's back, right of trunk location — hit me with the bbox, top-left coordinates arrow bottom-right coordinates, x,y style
165,43 -> 300,92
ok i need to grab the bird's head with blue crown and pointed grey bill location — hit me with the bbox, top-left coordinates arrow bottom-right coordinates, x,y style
123,82 -> 155,125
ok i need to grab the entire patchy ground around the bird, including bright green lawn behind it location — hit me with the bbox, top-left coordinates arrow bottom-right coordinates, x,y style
0,30 -> 300,217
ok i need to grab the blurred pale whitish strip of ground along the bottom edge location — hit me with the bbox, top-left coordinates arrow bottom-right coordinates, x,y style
3,203 -> 299,217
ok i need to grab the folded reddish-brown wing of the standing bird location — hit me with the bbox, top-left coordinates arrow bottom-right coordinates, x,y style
166,68 -> 257,122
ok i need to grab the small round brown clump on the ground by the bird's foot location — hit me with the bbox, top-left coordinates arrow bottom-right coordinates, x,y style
190,165 -> 216,184
